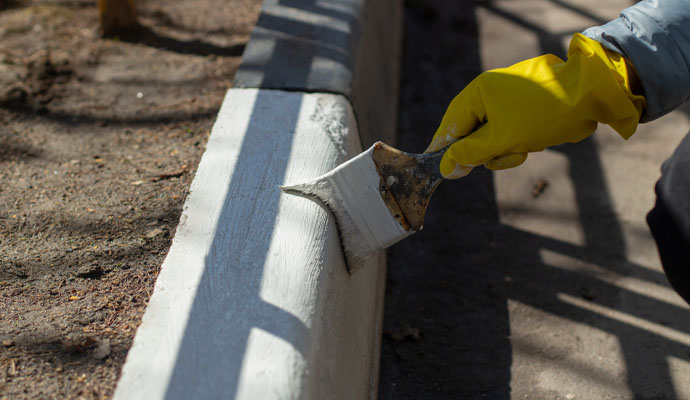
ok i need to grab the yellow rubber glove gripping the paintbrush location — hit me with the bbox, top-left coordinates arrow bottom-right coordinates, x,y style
426,34 -> 645,179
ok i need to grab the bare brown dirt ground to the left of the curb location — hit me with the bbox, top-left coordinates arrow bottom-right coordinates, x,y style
0,0 -> 261,399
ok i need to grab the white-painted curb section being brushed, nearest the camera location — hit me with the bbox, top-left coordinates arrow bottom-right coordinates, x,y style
114,89 -> 385,400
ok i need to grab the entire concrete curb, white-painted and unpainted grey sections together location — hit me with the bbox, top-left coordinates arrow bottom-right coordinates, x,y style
114,0 -> 401,400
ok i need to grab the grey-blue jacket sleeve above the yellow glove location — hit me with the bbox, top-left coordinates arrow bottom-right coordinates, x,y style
583,0 -> 690,122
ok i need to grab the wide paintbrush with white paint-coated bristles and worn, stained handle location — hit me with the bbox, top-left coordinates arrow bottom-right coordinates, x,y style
281,142 -> 445,274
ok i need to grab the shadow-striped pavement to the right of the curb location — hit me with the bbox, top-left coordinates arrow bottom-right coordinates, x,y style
380,0 -> 690,399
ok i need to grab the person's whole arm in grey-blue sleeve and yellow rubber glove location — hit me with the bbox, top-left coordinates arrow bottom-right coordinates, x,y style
427,0 -> 690,178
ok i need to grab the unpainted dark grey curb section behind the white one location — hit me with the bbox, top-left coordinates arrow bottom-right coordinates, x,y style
235,0 -> 402,148
